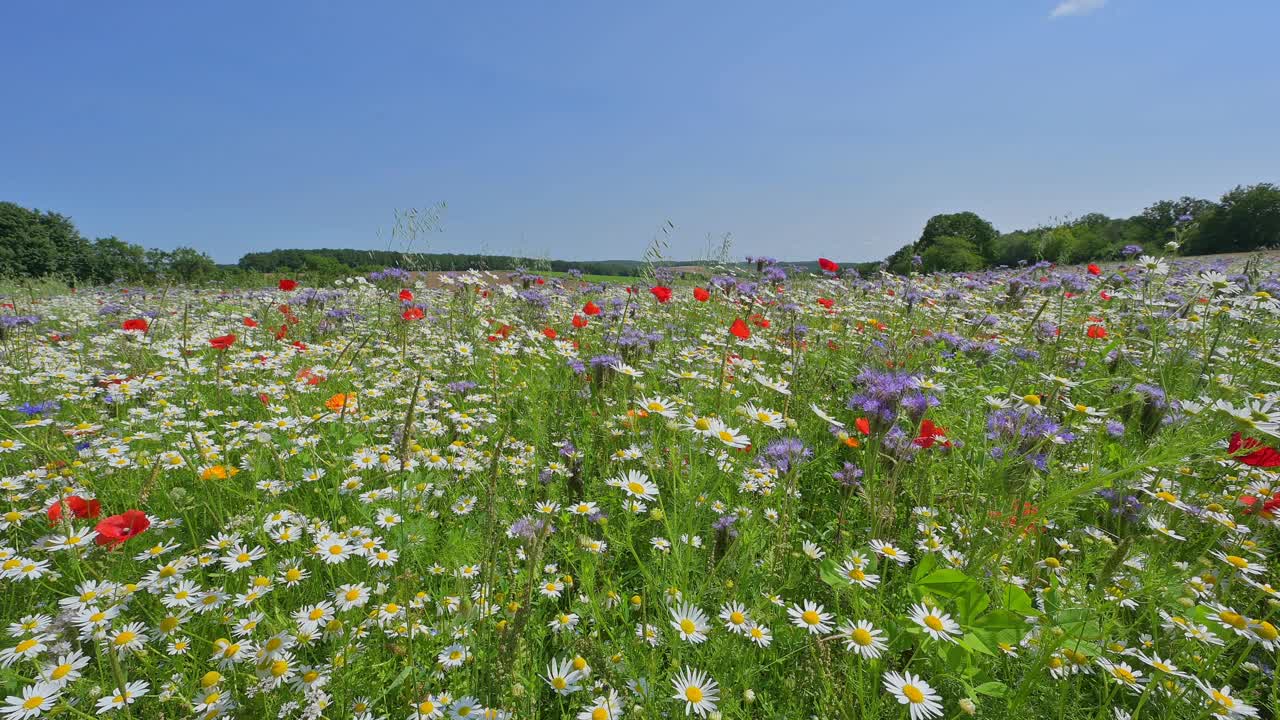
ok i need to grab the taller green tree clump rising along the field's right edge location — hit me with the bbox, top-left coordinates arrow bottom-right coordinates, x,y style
880,183 -> 1280,273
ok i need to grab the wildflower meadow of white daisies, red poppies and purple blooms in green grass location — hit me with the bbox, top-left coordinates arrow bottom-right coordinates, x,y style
0,256 -> 1280,720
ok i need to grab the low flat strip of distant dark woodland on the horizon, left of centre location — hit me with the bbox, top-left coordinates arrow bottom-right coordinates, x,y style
238,249 -> 643,275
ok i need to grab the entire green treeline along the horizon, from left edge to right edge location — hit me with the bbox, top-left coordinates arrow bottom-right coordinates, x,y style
10,183 -> 1280,284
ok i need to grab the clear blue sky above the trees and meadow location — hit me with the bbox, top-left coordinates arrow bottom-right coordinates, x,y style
0,0 -> 1280,261
